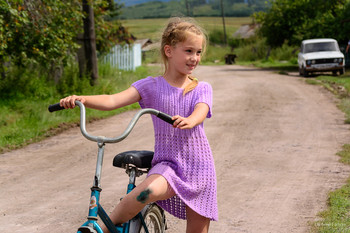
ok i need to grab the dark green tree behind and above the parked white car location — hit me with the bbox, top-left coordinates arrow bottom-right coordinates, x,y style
255,0 -> 349,47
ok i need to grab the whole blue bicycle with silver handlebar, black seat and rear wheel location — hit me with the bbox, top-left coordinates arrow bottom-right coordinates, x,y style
49,101 -> 174,233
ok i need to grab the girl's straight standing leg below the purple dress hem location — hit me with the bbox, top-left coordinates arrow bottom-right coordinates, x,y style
186,207 -> 210,233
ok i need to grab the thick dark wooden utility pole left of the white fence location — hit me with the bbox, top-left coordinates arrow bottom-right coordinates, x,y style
82,0 -> 98,85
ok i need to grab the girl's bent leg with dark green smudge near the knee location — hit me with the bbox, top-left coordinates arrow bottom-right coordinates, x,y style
102,174 -> 175,232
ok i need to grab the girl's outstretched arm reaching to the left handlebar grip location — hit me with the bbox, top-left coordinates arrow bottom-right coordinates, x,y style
60,86 -> 141,111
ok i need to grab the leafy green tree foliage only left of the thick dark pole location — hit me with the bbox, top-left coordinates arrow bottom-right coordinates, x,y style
0,0 -> 82,80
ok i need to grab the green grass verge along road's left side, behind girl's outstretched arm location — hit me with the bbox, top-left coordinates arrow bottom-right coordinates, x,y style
0,64 -> 158,153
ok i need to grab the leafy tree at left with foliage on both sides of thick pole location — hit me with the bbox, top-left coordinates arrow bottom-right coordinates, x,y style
0,0 -> 132,82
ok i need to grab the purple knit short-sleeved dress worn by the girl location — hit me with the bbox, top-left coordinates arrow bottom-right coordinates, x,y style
132,76 -> 218,221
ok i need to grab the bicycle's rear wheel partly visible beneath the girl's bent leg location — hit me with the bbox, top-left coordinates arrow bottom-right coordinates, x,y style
139,204 -> 166,233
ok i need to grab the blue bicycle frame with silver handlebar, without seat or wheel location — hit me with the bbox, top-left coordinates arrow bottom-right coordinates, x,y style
49,101 -> 173,233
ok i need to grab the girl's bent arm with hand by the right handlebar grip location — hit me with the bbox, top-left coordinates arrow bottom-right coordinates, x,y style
172,103 -> 209,129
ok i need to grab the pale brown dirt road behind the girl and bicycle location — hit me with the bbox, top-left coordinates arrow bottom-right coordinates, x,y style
0,66 -> 350,233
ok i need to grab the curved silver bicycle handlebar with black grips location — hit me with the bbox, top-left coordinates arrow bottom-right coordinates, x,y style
48,100 -> 174,143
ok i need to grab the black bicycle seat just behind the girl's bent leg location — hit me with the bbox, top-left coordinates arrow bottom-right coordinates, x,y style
113,150 -> 154,168
